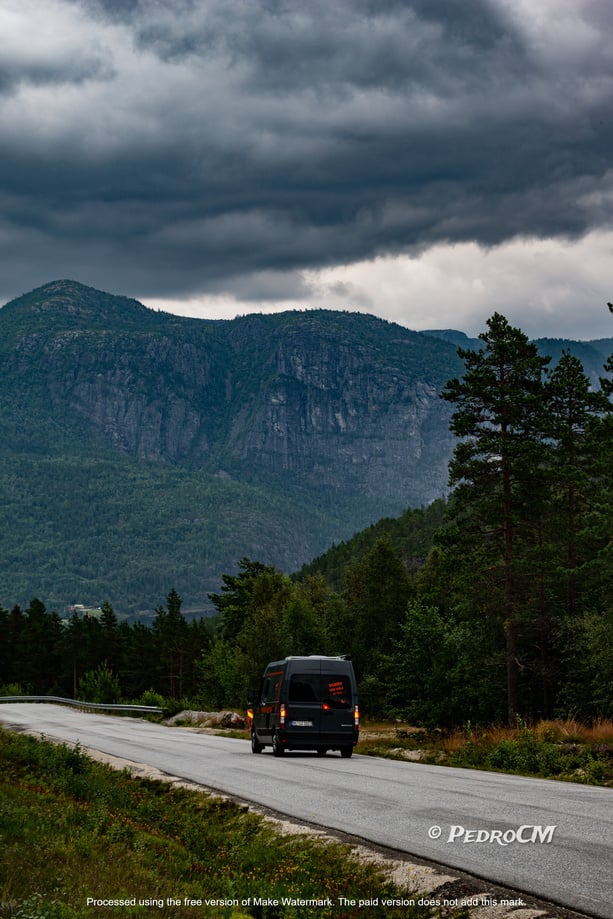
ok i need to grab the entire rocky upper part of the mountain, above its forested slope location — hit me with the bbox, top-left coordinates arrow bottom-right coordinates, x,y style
0,282 -> 457,512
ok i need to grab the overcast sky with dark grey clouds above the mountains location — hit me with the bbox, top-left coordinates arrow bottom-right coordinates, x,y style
0,0 -> 613,338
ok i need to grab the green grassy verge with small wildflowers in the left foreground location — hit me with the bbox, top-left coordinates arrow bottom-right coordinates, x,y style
0,729 -> 436,919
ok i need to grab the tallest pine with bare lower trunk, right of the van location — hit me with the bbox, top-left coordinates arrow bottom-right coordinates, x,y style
441,313 -> 549,723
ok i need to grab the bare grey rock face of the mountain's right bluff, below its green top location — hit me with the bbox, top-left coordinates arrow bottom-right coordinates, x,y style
229,335 -> 451,505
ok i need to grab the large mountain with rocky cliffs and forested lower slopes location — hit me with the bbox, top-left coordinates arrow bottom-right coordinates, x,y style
0,281 -> 608,612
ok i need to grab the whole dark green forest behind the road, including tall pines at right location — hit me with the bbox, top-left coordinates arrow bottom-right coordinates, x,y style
0,314 -> 613,728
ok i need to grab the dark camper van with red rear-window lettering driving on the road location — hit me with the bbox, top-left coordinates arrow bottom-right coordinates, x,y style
248,654 -> 360,757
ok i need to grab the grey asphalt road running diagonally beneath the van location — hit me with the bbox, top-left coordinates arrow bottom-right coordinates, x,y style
0,703 -> 613,919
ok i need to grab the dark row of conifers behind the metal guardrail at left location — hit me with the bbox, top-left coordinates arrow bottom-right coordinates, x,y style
0,590 -> 211,706
